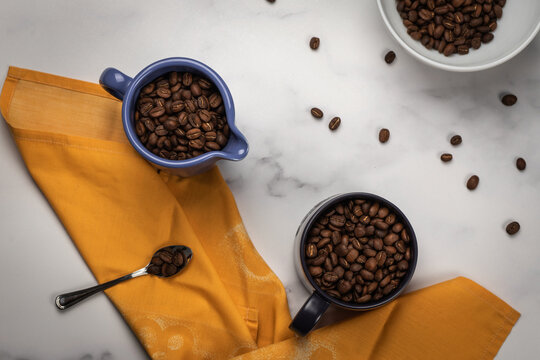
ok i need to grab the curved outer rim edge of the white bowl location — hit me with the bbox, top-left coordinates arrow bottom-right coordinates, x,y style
377,0 -> 540,72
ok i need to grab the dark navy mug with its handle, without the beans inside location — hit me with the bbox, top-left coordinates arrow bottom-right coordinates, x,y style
289,192 -> 418,336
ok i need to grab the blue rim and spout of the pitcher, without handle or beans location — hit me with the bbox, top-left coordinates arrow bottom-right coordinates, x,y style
122,57 -> 248,169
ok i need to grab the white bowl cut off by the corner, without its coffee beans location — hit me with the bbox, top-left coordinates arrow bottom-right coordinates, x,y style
377,0 -> 540,72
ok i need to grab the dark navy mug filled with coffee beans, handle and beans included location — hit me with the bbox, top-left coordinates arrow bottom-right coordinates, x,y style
290,193 -> 418,335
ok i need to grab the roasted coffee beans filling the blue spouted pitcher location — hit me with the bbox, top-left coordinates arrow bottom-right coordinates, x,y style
134,71 -> 230,160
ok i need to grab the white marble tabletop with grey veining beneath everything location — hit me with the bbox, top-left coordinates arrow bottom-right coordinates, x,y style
0,0 -> 540,360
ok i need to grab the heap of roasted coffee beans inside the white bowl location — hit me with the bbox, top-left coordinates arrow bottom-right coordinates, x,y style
396,0 -> 506,56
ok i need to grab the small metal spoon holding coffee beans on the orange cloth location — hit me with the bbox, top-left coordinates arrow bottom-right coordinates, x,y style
54,245 -> 193,310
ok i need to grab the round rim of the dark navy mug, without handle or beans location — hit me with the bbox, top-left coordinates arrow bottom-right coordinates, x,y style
299,192 -> 418,310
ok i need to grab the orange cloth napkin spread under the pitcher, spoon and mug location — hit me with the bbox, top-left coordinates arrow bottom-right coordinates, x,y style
0,68 -> 519,359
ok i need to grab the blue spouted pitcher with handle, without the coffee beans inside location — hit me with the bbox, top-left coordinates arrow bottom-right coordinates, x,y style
99,57 -> 249,177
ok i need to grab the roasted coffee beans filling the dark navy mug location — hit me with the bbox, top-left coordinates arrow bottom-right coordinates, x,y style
304,199 -> 411,303
